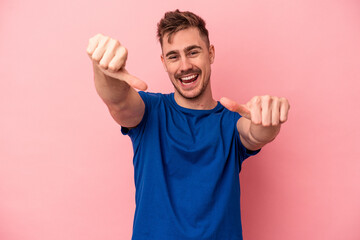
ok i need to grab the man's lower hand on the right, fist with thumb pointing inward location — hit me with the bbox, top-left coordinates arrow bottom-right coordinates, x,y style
220,95 -> 290,127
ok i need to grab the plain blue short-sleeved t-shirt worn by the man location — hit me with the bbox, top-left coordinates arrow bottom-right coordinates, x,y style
122,92 -> 258,240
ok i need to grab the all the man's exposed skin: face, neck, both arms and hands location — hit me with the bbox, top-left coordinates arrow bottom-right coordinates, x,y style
87,28 -> 290,150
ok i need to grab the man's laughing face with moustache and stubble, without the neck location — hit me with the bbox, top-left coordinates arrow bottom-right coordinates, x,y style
161,28 -> 215,99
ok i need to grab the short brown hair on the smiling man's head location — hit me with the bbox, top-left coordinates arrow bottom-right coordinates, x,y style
157,9 -> 210,46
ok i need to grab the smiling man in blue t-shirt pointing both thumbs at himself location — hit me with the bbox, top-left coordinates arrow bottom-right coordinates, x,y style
87,10 -> 289,240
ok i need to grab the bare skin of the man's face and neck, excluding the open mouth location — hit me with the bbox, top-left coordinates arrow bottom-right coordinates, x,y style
161,28 -> 217,109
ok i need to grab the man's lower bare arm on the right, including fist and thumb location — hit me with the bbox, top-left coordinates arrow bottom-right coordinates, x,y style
220,95 -> 290,150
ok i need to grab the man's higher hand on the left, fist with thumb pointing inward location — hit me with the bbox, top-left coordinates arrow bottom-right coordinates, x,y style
87,34 -> 147,90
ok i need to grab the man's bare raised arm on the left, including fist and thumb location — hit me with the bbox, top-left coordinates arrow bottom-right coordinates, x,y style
87,34 -> 147,128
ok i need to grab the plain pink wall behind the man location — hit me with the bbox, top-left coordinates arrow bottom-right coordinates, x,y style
0,0 -> 360,240
